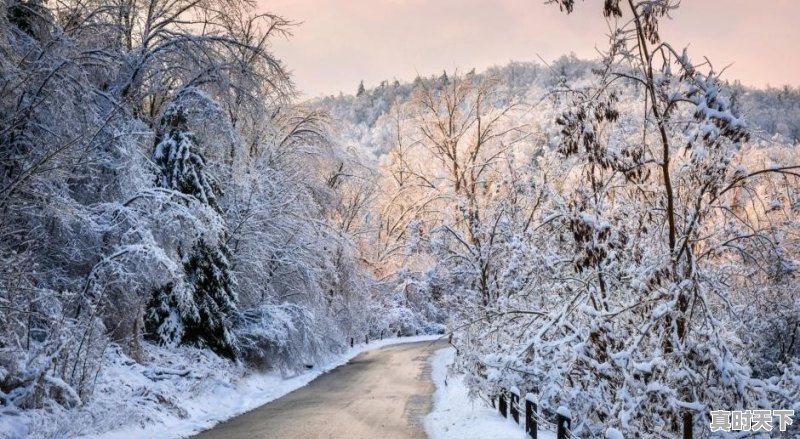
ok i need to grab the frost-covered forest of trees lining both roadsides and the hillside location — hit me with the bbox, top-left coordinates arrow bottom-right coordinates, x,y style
0,0 -> 800,437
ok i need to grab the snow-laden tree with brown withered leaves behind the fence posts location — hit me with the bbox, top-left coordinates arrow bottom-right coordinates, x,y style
444,0 -> 798,437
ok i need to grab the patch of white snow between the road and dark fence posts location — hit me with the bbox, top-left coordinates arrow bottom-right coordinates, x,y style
425,348 -> 555,439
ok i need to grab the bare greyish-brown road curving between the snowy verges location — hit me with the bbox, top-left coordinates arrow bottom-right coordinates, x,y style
191,341 -> 447,439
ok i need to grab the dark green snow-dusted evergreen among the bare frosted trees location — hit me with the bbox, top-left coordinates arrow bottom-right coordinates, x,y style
146,107 -> 238,359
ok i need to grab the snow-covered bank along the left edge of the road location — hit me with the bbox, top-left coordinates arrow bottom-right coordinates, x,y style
0,335 -> 440,439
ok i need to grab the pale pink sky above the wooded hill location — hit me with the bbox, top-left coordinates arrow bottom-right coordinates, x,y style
259,0 -> 800,96
